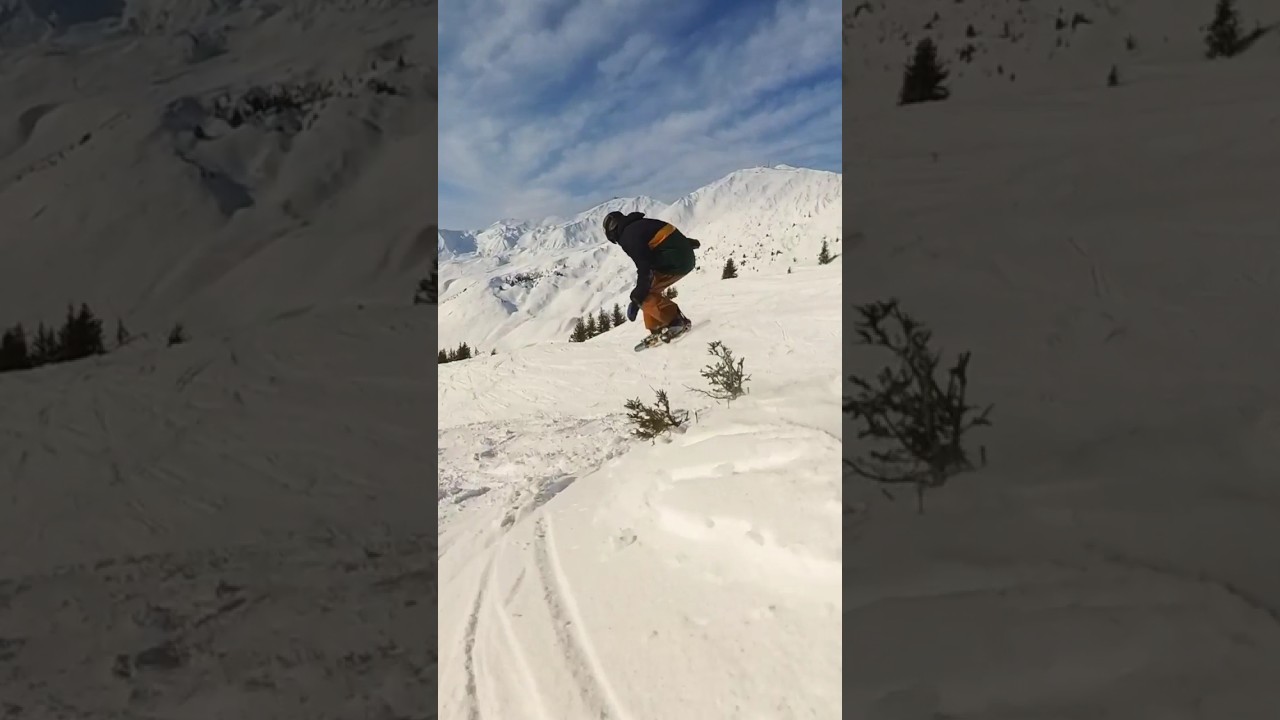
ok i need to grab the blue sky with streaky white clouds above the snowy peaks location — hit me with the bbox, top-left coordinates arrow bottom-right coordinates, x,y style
439,0 -> 841,229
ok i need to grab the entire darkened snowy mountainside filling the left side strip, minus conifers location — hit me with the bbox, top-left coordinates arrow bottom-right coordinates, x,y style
0,0 -> 436,720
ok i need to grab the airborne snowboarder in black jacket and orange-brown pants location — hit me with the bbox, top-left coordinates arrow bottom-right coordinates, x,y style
604,210 -> 701,343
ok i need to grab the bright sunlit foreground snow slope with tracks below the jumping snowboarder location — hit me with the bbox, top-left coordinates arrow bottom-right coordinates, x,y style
438,265 -> 841,720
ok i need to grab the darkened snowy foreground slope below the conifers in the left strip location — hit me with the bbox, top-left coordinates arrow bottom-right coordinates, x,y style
0,301 -> 435,720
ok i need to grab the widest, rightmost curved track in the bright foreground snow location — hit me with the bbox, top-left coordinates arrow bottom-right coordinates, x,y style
534,515 -> 627,720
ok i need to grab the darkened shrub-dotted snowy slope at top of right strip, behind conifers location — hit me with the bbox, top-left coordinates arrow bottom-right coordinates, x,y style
845,0 -> 1280,113
